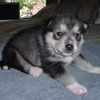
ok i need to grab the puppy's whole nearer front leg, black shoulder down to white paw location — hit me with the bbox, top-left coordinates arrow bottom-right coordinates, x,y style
43,61 -> 87,94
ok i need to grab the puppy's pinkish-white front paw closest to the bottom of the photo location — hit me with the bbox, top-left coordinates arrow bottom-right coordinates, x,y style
66,83 -> 87,94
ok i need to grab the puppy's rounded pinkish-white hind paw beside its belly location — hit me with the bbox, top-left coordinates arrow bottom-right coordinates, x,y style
29,67 -> 43,77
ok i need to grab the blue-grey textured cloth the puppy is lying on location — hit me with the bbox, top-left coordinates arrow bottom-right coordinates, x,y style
0,43 -> 100,100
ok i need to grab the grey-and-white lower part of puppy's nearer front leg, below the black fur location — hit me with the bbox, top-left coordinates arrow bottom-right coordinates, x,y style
56,72 -> 87,94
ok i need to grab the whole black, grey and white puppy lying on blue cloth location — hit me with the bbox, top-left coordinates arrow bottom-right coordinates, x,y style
0,13 -> 100,94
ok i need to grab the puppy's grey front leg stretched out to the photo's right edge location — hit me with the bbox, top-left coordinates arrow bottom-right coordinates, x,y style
72,54 -> 100,74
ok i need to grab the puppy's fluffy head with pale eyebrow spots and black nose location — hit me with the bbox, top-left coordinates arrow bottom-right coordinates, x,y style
46,13 -> 87,57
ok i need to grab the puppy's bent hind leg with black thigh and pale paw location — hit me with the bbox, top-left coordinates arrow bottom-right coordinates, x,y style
1,47 -> 42,77
